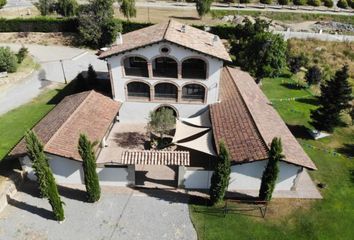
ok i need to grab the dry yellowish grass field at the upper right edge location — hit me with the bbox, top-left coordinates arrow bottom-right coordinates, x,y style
288,39 -> 354,78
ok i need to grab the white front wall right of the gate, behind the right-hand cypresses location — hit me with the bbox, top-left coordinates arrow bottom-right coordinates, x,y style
184,161 -> 302,191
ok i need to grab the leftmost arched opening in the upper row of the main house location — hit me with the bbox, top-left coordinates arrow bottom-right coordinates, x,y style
124,57 -> 149,77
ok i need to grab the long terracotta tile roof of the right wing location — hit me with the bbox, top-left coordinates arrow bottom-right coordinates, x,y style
211,68 -> 317,169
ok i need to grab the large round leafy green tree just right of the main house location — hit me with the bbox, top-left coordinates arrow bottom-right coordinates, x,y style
231,19 -> 286,80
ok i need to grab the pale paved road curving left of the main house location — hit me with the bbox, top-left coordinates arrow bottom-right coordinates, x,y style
0,44 -> 107,114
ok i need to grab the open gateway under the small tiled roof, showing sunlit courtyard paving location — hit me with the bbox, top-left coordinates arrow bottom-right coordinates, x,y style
135,165 -> 178,188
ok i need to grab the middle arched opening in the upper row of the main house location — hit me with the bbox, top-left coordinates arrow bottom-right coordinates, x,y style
152,57 -> 177,78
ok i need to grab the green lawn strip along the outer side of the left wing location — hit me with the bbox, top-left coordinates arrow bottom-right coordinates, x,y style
0,85 -> 63,161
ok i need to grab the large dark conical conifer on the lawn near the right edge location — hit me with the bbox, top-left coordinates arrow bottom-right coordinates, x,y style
311,66 -> 352,132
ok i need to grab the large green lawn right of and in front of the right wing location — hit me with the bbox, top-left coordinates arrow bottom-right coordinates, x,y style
190,78 -> 354,240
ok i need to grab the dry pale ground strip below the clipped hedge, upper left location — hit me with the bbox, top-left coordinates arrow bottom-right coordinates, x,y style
0,32 -> 77,46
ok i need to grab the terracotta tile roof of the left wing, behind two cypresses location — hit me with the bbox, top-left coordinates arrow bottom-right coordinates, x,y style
10,91 -> 120,161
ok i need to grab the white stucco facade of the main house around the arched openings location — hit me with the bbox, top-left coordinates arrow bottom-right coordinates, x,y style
107,43 -> 223,122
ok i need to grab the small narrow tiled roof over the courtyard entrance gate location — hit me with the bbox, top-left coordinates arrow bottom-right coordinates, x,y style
122,150 -> 189,166
